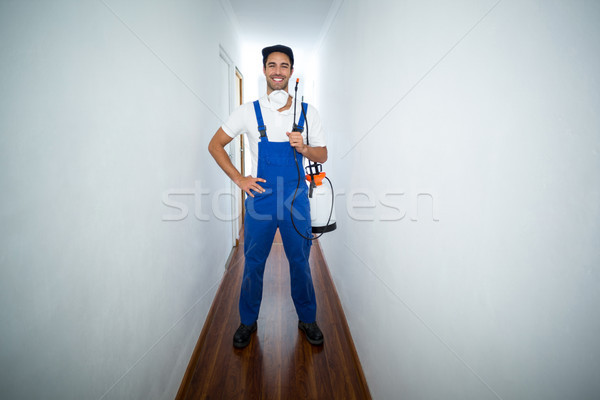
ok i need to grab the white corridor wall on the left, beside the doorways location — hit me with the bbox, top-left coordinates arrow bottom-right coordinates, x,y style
0,0 -> 240,400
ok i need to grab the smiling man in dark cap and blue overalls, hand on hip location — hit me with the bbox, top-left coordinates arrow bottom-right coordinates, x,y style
208,45 -> 327,348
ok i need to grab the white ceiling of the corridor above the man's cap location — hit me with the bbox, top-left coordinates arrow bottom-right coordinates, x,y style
229,0 -> 334,67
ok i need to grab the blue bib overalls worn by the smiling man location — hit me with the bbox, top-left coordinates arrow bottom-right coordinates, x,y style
239,100 -> 317,325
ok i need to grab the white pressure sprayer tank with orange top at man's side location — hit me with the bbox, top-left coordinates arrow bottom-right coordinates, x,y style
306,172 -> 337,233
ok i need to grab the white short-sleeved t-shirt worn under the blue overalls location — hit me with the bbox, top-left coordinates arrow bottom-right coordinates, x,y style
221,94 -> 325,177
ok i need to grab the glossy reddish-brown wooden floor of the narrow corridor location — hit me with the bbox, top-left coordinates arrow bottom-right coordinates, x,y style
177,230 -> 371,400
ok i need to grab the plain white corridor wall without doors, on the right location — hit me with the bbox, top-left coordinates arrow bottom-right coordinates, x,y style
316,0 -> 600,399
